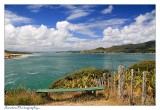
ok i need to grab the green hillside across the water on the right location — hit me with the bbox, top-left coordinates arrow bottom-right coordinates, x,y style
81,41 -> 155,53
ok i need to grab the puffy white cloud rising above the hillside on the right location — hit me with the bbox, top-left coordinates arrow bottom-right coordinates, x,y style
103,10 -> 156,44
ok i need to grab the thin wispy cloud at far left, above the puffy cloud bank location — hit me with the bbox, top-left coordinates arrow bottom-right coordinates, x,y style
5,10 -> 32,24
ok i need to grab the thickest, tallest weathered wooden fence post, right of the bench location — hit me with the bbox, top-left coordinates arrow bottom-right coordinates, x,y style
118,65 -> 124,98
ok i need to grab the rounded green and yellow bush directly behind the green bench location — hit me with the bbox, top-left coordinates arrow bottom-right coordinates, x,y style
49,68 -> 110,89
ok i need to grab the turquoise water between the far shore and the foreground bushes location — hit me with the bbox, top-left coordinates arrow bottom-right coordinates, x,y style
5,53 -> 155,89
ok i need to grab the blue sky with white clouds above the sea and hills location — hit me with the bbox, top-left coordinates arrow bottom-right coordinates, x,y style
4,5 -> 156,52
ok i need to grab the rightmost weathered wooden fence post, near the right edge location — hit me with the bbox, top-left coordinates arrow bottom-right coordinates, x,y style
142,71 -> 146,105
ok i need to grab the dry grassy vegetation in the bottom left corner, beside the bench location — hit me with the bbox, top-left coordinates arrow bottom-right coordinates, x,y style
5,86 -> 49,105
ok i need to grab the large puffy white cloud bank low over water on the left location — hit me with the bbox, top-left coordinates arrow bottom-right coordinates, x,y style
5,21 -> 87,51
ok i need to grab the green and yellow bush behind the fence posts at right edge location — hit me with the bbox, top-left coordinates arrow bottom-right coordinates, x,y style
125,60 -> 156,98
